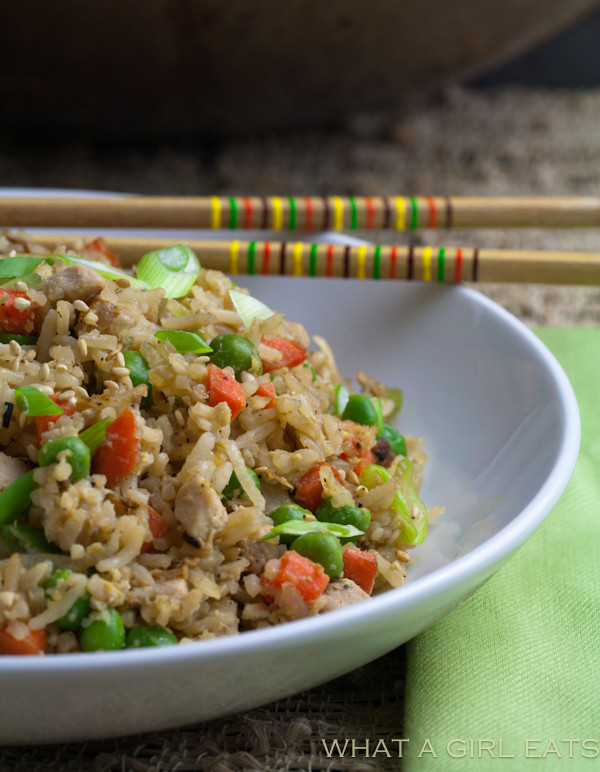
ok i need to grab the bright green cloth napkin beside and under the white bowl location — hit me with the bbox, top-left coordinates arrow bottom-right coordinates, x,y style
402,328 -> 600,772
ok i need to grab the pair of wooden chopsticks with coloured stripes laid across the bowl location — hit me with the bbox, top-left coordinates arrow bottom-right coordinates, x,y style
0,196 -> 600,285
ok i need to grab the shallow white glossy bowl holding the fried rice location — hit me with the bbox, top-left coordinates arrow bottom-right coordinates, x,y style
0,277 -> 580,744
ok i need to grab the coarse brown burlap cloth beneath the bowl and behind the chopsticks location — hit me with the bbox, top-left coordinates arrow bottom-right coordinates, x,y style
0,88 -> 600,772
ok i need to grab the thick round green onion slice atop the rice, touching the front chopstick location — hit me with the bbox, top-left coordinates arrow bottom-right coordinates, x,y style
137,244 -> 201,298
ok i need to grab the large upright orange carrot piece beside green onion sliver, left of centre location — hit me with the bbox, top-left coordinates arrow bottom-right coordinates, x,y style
92,407 -> 140,487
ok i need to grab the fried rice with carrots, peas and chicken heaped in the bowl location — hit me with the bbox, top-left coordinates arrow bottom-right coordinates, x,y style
0,236 -> 435,654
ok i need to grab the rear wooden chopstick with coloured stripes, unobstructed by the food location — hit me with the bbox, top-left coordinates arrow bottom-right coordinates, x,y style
0,196 -> 600,232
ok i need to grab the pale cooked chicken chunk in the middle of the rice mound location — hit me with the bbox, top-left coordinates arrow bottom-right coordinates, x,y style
174,474 -> 227,545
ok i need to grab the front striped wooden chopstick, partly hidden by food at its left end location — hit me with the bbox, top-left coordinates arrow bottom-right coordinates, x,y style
19,233 -> 600,285
